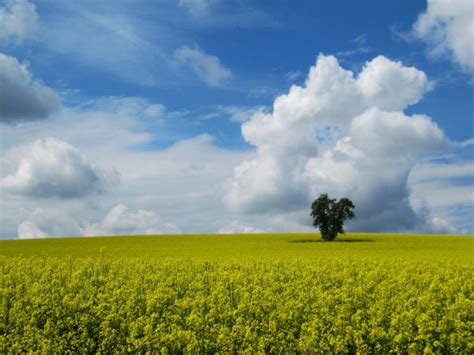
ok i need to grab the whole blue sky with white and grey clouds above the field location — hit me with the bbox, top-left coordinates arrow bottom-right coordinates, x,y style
0,0 -> 474,239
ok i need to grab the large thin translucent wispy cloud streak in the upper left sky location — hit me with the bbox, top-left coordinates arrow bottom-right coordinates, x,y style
41,3 -> 167,85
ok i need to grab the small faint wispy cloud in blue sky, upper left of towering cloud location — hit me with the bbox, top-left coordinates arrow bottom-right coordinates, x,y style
173,46 -> 232,86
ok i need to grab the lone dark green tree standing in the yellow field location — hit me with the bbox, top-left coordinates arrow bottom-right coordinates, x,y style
311,194 -> 355,240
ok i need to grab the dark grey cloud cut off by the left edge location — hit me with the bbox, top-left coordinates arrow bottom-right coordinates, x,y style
0,53 -> 60,122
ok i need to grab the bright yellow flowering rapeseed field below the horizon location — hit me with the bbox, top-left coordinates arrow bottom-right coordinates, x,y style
0,234 -> 474,354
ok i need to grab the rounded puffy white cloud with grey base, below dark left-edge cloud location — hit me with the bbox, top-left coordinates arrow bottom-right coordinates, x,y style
0,138 -> 118,198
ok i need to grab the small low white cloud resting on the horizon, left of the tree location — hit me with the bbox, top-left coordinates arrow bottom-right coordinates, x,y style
83,204 -> 181,236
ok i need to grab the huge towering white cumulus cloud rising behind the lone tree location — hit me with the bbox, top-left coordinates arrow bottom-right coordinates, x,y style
226,55 -> 446,231
